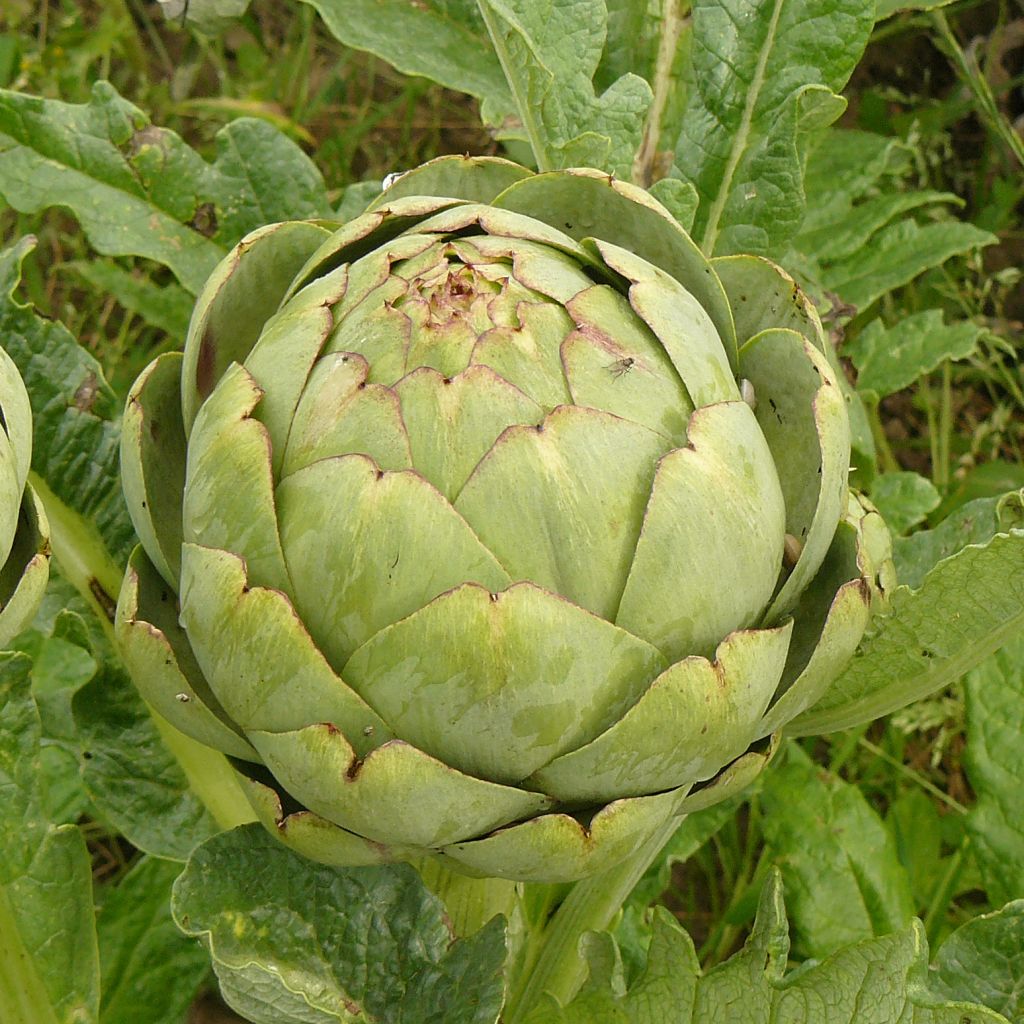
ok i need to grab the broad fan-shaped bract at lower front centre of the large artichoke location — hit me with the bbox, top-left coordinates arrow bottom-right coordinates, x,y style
343,583 -> 666,785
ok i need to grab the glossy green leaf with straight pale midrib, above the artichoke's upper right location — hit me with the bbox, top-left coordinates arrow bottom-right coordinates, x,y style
675,0 -> 873,254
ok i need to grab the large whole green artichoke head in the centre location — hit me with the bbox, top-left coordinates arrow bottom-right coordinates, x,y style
117,158 -> 888,881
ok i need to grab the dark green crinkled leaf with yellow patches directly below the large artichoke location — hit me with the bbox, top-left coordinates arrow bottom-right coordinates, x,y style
173,826 -> 505,1024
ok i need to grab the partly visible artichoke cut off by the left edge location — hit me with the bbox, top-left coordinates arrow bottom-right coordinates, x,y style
0,348 -> 50,647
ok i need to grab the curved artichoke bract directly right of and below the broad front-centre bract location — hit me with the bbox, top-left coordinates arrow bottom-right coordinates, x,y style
525,623 -> 793,805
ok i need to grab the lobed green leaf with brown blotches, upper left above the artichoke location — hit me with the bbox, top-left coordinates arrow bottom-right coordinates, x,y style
0,82 -> 331,294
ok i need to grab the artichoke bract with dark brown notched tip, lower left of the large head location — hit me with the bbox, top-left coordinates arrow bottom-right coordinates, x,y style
250,724 -> 552,852
